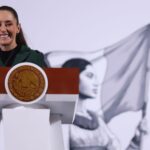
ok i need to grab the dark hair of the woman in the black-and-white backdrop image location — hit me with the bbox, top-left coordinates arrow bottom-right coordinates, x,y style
62,58 -> 91,73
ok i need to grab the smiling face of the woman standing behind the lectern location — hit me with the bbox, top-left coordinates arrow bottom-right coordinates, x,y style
0,10 -> 20,50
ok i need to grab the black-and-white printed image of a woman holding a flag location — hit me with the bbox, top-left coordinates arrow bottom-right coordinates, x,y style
47,25 -> 150,150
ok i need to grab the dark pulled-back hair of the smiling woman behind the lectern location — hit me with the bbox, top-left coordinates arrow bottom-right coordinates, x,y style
0,6 -> 27,46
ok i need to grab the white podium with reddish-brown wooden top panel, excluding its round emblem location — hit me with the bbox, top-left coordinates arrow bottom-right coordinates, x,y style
0,63 -> 78,150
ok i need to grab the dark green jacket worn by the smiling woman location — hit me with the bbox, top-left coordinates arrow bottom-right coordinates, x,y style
0,45 -> 46,67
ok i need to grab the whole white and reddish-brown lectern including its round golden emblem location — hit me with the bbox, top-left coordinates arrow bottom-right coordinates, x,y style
0,63 -> 79,150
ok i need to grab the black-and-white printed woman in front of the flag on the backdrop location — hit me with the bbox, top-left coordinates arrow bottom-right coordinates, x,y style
62,58 -> 120,150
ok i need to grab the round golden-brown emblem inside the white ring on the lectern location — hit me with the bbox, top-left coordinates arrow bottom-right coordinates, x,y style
8,65 -> 45,102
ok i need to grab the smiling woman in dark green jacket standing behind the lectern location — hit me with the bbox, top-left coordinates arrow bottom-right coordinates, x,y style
0,6 -> 46,67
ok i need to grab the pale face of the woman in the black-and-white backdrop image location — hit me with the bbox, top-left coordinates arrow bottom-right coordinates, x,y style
79,65 -> 98,98
